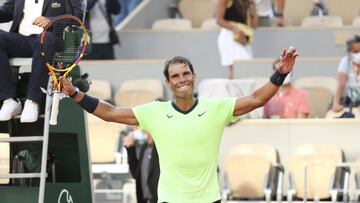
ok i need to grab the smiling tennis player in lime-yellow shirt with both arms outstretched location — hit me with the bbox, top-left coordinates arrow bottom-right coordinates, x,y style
61,48 -> 298,203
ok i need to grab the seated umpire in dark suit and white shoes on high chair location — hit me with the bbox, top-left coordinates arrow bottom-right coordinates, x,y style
0,0 -> 83,123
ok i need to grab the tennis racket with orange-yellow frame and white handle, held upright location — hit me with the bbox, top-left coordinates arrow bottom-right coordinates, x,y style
40,15 -> 88,125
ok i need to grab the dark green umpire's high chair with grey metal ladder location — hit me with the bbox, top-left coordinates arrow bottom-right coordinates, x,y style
0,58 -> 94,203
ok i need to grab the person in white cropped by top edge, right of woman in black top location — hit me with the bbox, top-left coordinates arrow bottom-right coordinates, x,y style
255,0 -> 285,27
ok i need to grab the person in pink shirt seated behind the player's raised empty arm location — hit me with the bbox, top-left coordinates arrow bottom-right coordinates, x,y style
264,60 -> 310,118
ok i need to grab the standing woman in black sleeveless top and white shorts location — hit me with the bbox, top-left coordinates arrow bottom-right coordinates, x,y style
216,0 -> 258,79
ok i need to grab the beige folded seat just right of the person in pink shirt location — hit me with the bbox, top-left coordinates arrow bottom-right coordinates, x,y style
294,76 -> 337,118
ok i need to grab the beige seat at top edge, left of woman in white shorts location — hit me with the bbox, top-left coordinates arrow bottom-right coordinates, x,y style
178,0 -> 215,28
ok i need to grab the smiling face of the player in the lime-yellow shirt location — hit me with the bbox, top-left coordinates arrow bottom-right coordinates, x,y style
166,63 -> 196,99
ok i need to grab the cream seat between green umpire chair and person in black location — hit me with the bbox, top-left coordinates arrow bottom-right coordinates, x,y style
87,113 -> 131,199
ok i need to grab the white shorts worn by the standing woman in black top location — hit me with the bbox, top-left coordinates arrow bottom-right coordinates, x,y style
218,28 -> 253,66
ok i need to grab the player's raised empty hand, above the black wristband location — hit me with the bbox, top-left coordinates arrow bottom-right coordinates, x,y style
277,46 -> 299,74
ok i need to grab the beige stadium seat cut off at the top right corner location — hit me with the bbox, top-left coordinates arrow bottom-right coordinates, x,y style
325,0 -> 360,25
